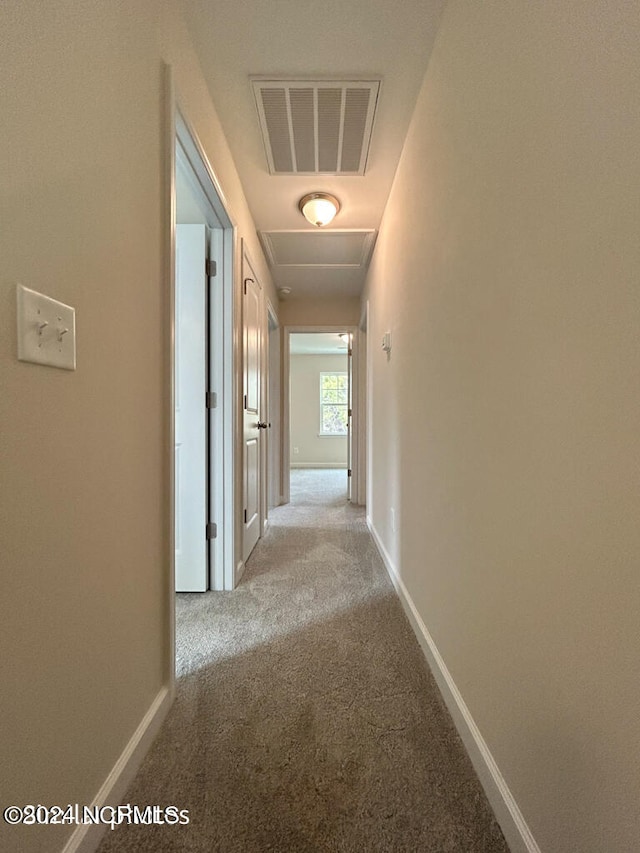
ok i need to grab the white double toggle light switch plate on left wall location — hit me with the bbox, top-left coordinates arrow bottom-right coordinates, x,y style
17,284 -> 76,370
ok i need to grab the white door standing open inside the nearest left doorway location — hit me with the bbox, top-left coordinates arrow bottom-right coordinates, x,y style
175,225 -> 208,592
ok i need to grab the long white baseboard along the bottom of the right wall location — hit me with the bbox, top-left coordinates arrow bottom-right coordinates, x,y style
367,516 -> 540,853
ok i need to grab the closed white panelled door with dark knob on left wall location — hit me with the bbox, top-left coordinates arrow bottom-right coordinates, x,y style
242,258 -> 267,561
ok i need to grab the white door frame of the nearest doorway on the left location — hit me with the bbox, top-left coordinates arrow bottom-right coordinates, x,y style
162,64 -> 238,684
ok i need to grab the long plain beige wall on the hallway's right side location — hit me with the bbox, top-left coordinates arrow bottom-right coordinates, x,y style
368,0 -> 640,853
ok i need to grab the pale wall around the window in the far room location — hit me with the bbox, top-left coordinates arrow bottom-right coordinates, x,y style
289,355 -> 347,468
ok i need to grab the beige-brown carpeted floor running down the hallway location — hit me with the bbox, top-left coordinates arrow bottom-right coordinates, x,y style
100,470 -> 508,853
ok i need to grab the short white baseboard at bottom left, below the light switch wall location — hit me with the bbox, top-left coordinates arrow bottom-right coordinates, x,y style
62,686 -> 173,853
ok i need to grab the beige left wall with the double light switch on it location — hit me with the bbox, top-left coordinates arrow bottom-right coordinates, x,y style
0,0 -> 276,853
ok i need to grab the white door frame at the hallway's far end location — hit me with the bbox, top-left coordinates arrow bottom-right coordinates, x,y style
281,323 -> 362,503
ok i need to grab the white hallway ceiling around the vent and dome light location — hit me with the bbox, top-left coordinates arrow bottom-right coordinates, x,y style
183,0 -> 444,298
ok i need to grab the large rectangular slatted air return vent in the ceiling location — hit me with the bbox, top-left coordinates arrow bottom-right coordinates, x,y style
251,78 -> 380,175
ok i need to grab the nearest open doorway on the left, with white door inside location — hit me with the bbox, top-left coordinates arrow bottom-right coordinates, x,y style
172,111 -> 234,592
